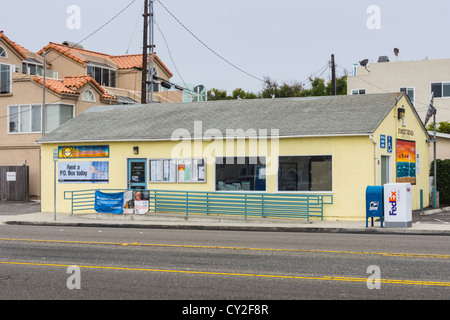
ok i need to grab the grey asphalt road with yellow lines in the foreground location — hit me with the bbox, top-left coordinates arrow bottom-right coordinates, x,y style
0,225 -> 450,304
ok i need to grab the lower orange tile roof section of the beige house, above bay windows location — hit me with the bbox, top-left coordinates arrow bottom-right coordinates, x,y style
33,75 -> 117,100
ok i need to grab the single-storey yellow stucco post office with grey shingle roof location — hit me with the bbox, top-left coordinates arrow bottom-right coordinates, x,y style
38,93 -> 429,220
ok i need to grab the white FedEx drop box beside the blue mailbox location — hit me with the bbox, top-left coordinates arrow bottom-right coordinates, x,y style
384,183 -> 412,228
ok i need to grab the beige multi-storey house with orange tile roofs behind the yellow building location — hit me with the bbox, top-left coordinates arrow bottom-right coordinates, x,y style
0,31 -> 182,199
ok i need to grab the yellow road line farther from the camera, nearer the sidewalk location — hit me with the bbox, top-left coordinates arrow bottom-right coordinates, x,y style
0,238 -> 450,259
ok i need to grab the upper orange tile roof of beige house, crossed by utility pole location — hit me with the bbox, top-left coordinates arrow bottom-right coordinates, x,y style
37,42 -> 173,77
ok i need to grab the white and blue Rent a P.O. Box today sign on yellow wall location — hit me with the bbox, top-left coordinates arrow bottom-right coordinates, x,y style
58,161 -> 109,183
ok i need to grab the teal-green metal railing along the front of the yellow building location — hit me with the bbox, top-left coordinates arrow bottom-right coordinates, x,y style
64,189 -> 333,221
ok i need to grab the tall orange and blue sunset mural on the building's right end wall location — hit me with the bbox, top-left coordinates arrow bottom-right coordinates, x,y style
397,140 -> 416,184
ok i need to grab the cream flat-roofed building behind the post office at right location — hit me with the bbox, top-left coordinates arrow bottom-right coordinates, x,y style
347,57 -> 450,125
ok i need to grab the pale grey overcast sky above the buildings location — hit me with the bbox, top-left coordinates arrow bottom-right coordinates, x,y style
0,0 -> 450,94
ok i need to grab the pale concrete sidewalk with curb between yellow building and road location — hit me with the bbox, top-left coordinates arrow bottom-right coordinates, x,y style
0,204 -> 450,235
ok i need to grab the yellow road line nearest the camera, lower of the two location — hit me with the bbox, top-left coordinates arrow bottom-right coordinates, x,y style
0,261 -> 450,287
